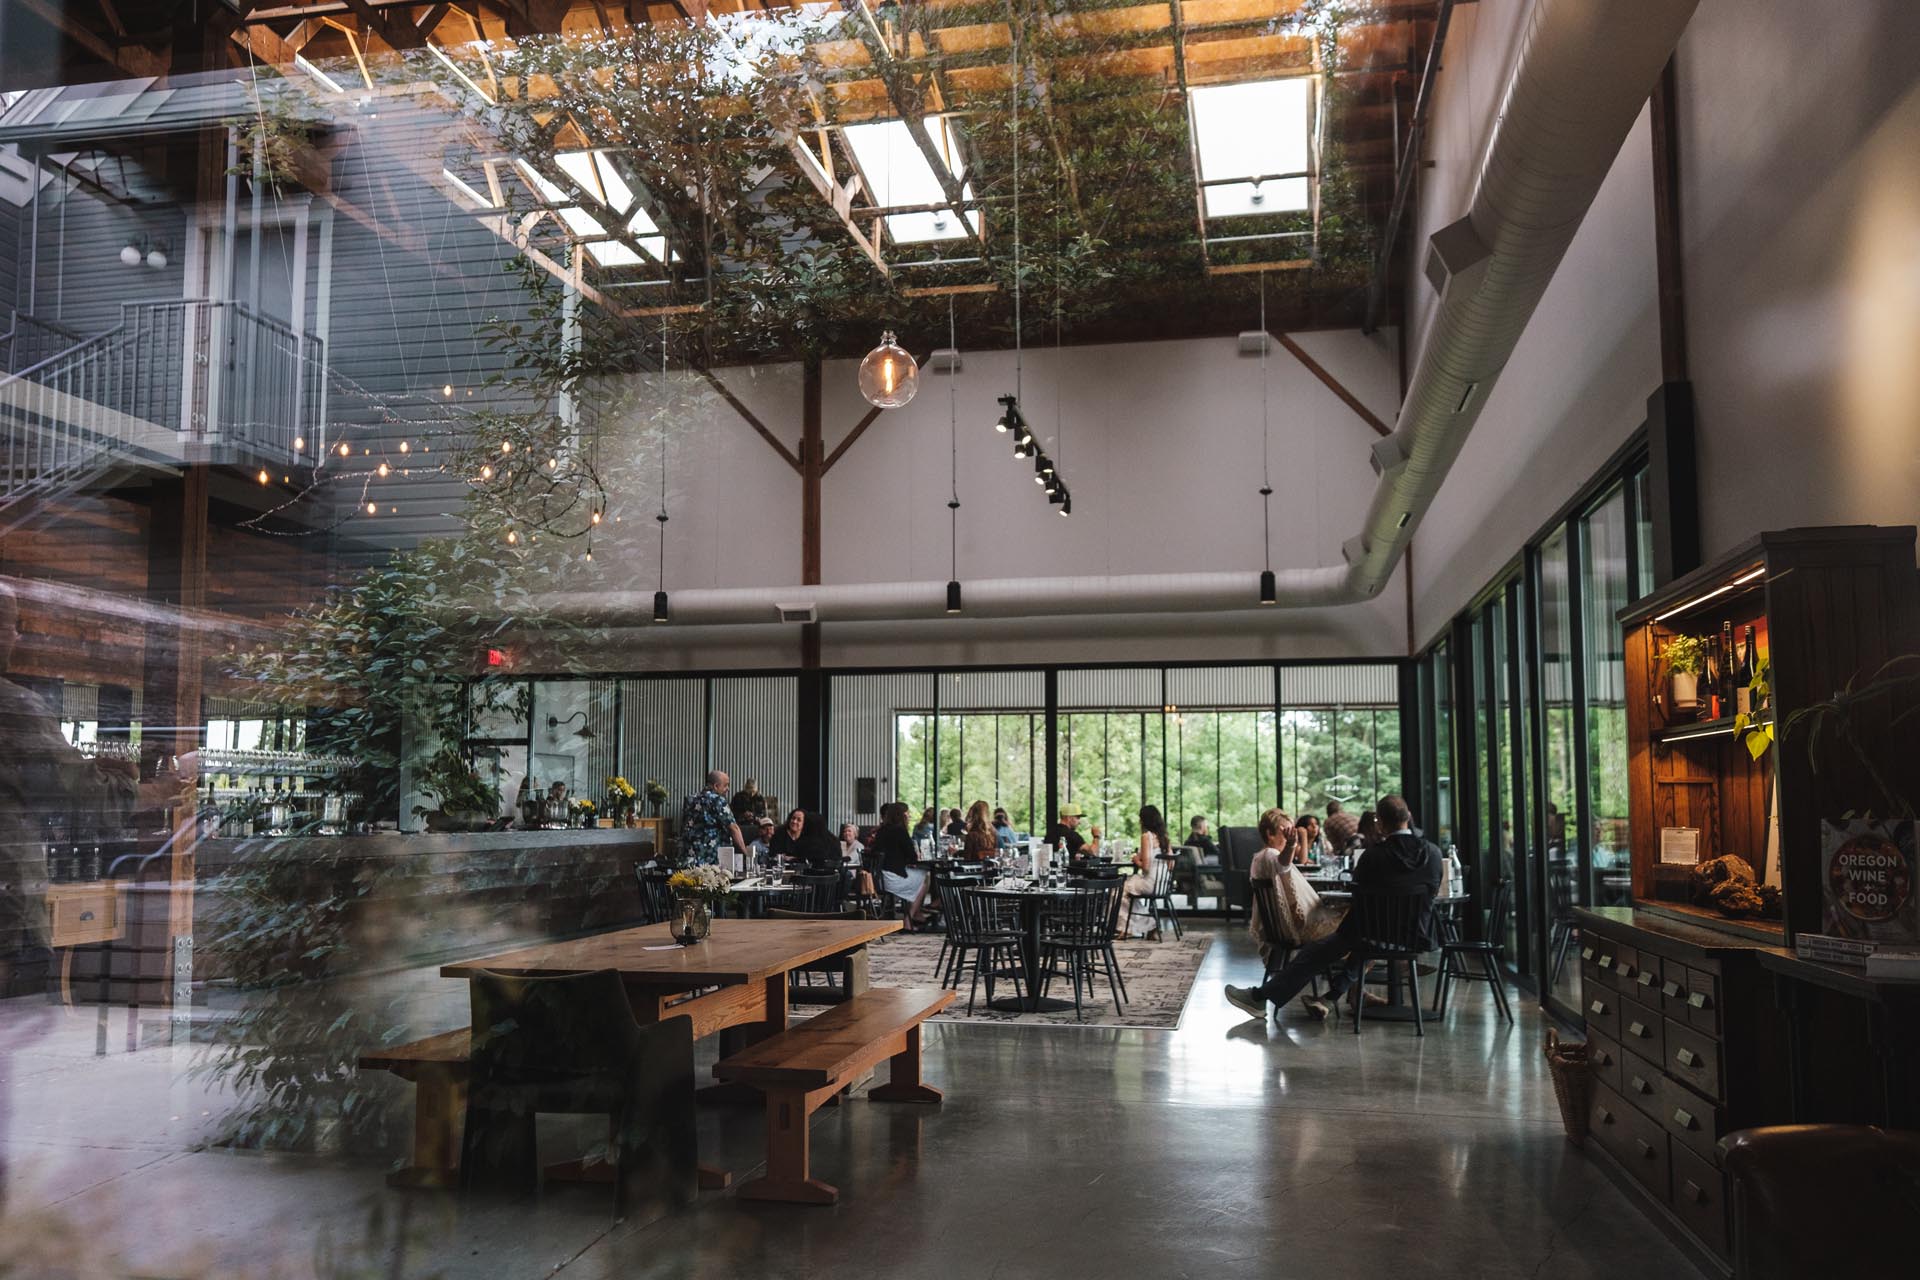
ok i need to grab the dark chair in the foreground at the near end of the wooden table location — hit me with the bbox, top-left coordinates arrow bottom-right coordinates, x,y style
461,969 -> 699,1217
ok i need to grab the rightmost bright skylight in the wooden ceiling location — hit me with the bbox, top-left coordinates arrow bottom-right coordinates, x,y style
1187,75 -> 1313,217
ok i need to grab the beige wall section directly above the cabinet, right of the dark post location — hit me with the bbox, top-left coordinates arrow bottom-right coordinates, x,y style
1678,0 -> 1920,557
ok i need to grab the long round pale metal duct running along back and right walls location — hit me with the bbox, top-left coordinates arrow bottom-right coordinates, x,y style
541,0 -> 1697,624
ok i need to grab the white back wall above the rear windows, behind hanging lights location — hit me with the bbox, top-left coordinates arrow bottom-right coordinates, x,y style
576,332 -> 1405,670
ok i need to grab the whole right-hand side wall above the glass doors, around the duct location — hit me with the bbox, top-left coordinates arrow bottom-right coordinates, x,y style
1409,0 -> 1920,643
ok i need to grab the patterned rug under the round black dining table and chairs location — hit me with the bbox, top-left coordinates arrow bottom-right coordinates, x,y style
848,933 -> 1213,1029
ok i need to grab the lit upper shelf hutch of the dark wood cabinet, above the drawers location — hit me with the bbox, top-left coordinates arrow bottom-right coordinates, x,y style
1620,526 -> 1920,940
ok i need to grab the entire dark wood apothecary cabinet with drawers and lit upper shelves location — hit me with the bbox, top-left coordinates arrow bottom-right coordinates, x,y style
1576,526 -> 1920,1268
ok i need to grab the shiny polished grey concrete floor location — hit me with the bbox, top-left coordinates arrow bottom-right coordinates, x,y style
0,927 -> 1697,1280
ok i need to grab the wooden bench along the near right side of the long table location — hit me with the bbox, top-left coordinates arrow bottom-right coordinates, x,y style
714,986 -> 960,1205
